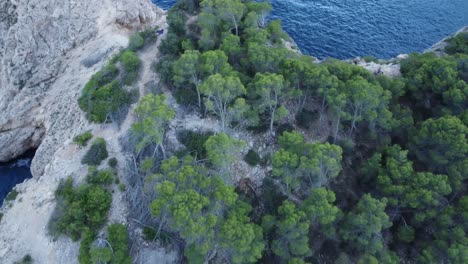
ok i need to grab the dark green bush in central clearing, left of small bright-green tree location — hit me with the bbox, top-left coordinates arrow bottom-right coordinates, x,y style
177,130 -> 213,160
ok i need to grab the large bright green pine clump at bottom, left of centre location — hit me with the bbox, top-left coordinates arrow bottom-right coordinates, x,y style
151,157 -> 264,263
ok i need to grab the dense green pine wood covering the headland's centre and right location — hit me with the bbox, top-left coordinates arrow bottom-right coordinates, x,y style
132,0 -> 468,264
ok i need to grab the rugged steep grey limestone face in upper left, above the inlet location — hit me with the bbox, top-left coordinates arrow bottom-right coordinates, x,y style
0,0 -> 163,176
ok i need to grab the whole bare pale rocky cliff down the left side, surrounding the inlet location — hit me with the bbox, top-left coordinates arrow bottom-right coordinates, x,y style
0,0 -> 165,263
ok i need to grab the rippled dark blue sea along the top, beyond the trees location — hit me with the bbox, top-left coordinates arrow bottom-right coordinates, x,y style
153,0 -> 468,59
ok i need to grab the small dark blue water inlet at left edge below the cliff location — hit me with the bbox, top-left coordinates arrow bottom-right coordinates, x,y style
0,154 -> 32,206
